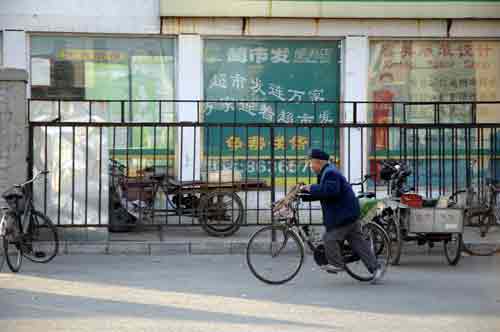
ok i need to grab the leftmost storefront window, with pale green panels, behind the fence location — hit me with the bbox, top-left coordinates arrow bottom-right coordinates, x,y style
30,35 -> 175,173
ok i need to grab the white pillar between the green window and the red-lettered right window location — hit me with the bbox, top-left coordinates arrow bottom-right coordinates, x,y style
342,36 -> 370,182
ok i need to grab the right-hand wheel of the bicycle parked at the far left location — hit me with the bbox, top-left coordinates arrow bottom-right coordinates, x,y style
23,211 -> 59,263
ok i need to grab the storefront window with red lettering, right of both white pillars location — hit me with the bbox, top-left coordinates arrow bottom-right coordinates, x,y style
368,40 -> 500,188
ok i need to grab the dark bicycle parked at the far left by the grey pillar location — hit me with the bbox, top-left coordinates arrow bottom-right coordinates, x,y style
0,171 -> 59,272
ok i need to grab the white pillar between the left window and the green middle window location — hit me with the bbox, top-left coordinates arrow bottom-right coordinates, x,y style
176,35 -> 203,181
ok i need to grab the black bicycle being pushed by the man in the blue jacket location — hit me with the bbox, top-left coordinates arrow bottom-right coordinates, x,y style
246,184 -> 391,284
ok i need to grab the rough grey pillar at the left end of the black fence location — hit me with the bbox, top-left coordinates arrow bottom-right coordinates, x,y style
0,67 -> 28,193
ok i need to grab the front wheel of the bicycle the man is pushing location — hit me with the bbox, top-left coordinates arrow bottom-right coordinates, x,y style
246,225 -> 305,285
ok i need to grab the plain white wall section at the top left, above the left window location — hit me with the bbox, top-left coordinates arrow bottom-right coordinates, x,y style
0,0 -> 160,34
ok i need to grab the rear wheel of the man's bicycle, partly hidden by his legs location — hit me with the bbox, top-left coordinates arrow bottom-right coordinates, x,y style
344,222 -> 391,281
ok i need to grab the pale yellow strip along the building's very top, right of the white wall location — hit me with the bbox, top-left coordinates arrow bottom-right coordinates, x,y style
160,0 -> 500,18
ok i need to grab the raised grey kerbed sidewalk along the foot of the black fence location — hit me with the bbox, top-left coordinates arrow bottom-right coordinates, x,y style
54,225 -> 500,255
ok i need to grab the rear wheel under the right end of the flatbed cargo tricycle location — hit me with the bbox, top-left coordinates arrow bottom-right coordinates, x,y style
199,192 -> 243,237
